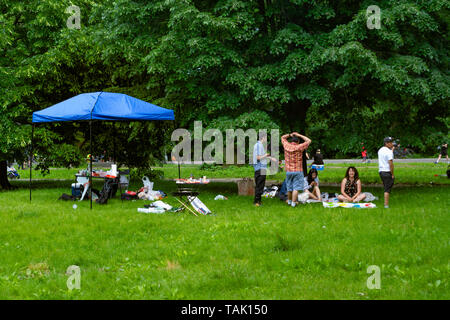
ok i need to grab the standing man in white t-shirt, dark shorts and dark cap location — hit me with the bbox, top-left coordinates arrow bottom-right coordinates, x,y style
378,137 -> 394,208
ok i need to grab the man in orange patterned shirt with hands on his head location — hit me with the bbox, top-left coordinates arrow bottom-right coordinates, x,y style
281,132 -> 311,207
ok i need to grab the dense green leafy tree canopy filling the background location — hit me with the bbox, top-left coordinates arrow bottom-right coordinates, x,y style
0,0 -> 450,188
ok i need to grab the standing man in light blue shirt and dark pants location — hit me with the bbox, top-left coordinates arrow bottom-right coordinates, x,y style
253,131 -> 277,207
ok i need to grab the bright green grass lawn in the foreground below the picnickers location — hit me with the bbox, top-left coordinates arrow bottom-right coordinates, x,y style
0,181 -> 450,300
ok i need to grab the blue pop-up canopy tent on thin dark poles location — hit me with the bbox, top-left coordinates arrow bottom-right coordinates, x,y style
30,92 -> 175,209
